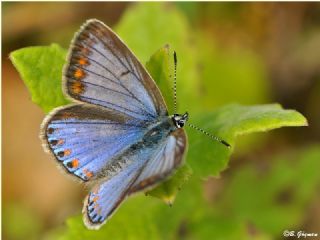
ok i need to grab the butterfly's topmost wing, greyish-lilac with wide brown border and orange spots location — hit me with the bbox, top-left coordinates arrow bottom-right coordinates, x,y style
64,20 -> 167,121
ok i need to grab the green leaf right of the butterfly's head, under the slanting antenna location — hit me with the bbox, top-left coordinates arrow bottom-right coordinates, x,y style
187,104 -> 307,177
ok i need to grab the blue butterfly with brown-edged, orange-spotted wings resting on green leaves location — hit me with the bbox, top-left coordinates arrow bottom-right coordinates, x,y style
41,19 -> 230,229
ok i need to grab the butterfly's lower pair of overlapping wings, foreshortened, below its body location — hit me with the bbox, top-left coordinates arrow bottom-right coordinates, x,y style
83,129 -> 187,228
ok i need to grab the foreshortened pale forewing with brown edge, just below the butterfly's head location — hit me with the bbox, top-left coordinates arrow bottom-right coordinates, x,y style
129,128 -> 187,193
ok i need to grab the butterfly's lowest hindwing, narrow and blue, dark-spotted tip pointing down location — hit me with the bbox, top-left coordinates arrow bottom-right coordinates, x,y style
84,127 -> 172,228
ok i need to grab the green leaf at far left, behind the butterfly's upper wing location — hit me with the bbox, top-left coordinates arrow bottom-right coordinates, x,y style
10,44 -> 69,113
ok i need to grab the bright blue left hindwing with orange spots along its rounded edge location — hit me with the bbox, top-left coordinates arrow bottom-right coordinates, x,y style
42,104 -> 144,181
